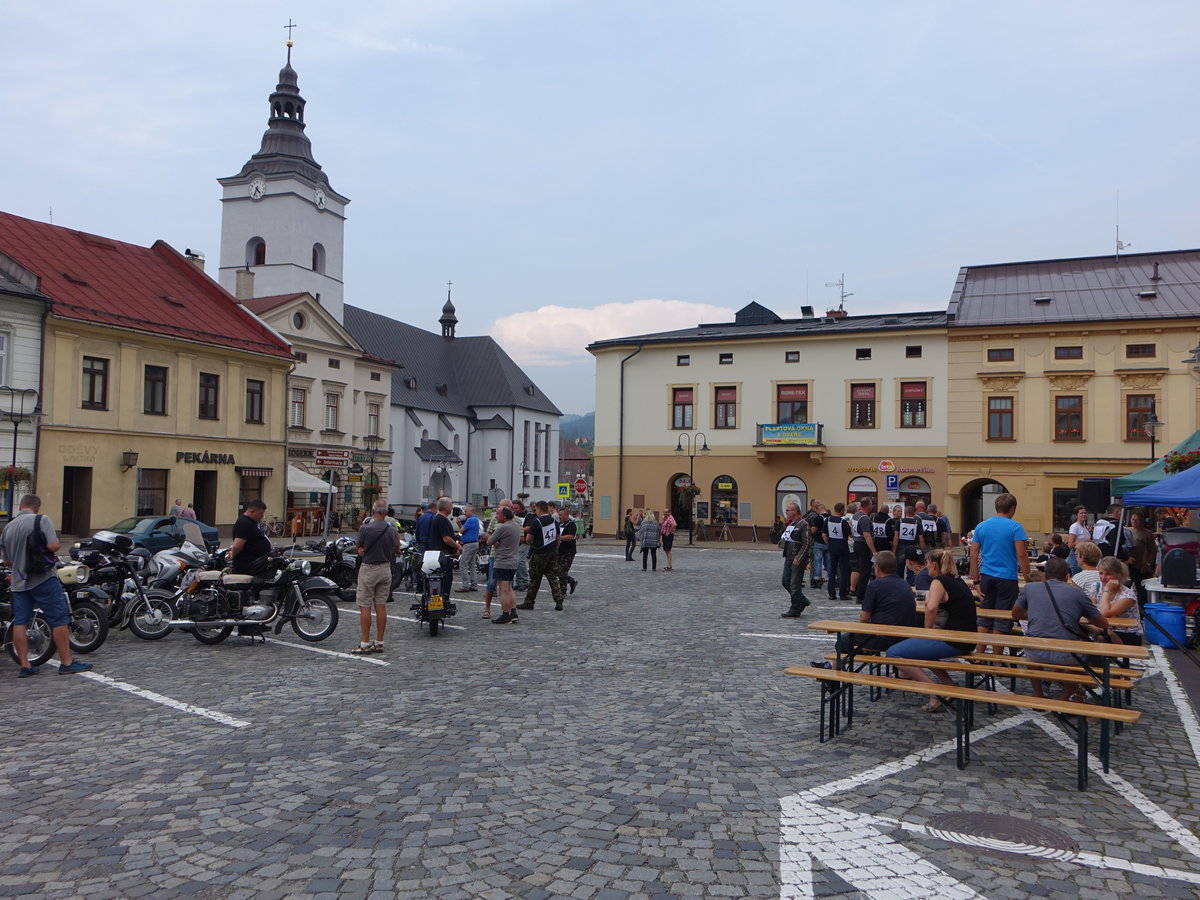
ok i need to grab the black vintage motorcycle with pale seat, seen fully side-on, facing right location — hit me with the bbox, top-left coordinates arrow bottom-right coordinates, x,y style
168,556 -> 337,644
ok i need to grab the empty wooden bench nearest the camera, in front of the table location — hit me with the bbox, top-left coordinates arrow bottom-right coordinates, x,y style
784,666 -> 1141,791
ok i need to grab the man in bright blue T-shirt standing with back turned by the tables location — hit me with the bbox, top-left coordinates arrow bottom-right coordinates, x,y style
971,493 -> 1030,653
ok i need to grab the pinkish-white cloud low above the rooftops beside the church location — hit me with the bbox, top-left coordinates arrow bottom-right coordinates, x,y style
491,299 -> 734,366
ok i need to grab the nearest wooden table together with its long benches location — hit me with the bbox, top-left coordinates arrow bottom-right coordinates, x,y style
784,610 -> 1150,791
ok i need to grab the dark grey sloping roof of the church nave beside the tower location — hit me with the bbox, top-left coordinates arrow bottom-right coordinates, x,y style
343,304 -> 562,418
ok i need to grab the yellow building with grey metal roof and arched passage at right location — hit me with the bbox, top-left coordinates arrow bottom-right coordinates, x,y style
947,251 -> 1200,533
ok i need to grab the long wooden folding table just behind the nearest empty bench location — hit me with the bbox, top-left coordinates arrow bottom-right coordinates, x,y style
809,619 -> 1150,772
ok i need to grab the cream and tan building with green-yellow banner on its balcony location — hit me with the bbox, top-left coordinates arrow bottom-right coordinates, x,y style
588,304 -> 947,539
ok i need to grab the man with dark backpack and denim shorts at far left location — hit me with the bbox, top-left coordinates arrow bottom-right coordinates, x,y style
0,493 -> 91,678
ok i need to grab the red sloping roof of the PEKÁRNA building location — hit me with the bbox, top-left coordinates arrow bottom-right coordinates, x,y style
0,212 -> 292,358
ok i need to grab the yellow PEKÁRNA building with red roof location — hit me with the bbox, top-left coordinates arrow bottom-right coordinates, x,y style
0,214 -> 292,534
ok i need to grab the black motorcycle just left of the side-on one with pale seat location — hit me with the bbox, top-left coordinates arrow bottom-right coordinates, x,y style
79,532 -> 175,641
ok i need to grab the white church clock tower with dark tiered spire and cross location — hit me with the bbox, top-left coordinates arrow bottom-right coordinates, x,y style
217,40 -> 349,322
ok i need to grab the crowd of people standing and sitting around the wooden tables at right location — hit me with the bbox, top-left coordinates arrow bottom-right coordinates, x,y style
780,493 -> 1175,712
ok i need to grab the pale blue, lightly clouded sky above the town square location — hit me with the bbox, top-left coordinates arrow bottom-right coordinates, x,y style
0,0 -> 1200,413
